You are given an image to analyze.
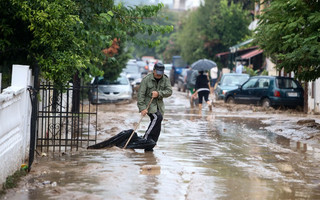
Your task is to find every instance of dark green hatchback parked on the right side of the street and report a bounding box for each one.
[224,76,303,107]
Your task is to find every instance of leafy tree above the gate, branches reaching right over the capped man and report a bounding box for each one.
[0,0,172,85]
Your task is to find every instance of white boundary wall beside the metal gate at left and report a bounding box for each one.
[0,65,32,186]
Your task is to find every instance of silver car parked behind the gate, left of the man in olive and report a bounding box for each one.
[89,73,132,104]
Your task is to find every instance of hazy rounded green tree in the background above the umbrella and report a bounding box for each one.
[178,0,250,63]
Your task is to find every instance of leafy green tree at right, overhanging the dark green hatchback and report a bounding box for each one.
[255,0,320,81]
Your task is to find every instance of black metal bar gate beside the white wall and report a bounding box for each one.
[36,82,98,152]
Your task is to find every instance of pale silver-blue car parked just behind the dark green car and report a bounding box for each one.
[214,73,250,100]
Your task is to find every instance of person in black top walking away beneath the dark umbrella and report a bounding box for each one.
[193,71,212,111]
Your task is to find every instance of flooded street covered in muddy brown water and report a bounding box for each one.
[3,91,320,200]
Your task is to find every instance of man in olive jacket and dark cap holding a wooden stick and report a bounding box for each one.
[137,63,172,151]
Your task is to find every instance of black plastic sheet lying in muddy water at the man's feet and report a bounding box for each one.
[87,129,156,149]
